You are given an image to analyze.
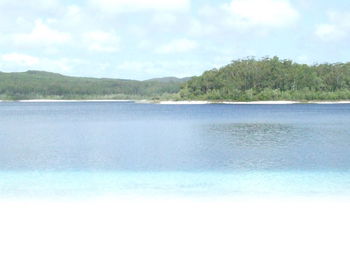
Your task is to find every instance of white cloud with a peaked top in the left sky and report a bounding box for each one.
[13,19,71,47]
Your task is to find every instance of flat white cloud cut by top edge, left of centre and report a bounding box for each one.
[90,0,190,12]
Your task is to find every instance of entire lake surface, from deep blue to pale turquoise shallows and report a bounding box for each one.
[0,102,350,196]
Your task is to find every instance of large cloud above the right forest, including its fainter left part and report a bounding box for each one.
[187,0,300,38]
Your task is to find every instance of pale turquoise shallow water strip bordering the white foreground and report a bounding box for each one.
[0,171,350,198]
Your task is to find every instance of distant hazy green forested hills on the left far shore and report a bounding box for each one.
[0,71,188,100]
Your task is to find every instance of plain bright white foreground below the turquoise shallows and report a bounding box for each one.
[0,198,350,263]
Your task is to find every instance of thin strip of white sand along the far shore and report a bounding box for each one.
[0,99,350,105]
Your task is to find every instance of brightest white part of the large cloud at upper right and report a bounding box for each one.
[224,0,299,27]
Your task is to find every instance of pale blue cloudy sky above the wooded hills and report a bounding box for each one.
[0,0,350,80]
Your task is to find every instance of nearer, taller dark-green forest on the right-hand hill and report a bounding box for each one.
[180,57,350,101]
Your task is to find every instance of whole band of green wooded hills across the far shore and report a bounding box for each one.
[0,57,350,101]
